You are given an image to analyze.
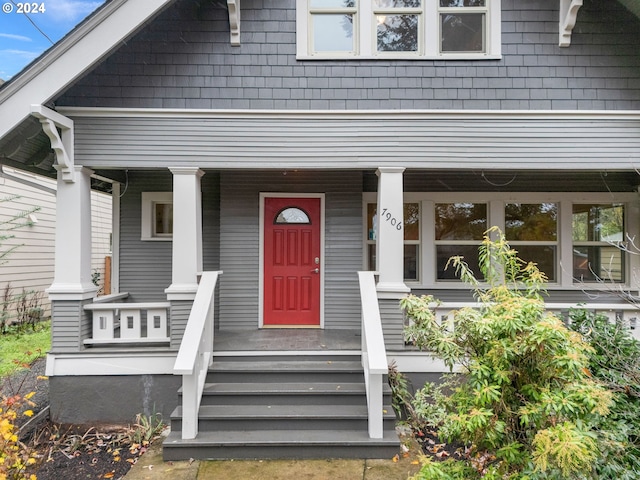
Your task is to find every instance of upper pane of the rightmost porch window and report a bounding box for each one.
[572,204,624,242]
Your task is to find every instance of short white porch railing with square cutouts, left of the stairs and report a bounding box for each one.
[83,293,170,345]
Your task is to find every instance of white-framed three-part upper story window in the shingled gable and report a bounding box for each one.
[296,0,501,59]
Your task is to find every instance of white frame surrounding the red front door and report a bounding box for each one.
[258,192,325,328]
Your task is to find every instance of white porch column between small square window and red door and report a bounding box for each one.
[165,167,204,300]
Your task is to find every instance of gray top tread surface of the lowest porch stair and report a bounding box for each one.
[163,430,399,447]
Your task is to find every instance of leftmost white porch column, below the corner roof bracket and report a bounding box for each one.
[47,166,98,300]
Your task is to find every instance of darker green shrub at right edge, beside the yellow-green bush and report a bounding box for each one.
[569,308,640,480]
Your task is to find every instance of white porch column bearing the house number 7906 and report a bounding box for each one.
[376,167,409,296]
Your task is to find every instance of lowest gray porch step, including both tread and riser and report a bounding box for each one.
[163,430,400,461]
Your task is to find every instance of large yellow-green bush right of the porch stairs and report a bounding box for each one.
[401,229,612,480]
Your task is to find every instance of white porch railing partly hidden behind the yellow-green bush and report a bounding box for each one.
[430,302,640,340]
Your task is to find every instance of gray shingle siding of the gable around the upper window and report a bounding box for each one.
[56,0,640,110]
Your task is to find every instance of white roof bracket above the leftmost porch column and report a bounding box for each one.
[31,105,75,183]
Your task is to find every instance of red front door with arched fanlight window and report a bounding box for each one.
[263,198,321,327]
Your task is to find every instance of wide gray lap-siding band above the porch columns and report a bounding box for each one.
[71,112,640,170]
